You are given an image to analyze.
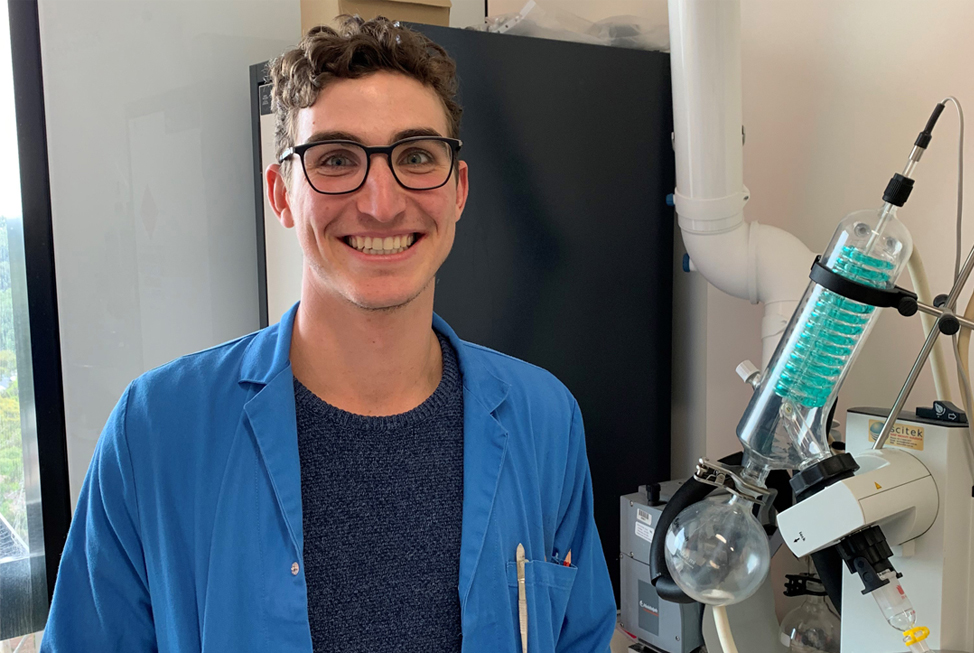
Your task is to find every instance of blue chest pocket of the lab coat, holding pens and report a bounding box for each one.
[507,561,578,653]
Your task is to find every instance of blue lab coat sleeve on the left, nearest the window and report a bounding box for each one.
[41,386,158,653]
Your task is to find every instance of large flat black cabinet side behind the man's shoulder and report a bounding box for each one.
[415,26,675,595]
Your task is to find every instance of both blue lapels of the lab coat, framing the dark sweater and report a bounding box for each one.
[240,304,510,604]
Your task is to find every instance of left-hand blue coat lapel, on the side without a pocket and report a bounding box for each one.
[240,304,304,559]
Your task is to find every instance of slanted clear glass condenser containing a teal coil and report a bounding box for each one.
[737,204,913,469]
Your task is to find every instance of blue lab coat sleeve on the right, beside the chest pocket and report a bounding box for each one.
[555,400,616,653]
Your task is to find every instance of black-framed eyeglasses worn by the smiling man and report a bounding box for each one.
[278,136,463,195]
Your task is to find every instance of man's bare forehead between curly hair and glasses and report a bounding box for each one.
[295,72,449,145]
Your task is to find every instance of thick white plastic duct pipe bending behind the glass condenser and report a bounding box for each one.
[669,0,815,368]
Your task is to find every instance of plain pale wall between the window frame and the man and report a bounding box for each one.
[39,0,300,502]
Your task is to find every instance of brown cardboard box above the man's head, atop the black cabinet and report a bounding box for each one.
[301,0,452,34]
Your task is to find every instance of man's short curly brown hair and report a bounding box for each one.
[269,16,463,183]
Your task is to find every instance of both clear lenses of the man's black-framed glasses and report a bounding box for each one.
[304,140,453,193]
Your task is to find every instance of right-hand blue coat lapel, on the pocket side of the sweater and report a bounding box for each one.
[433,314,510,604]
